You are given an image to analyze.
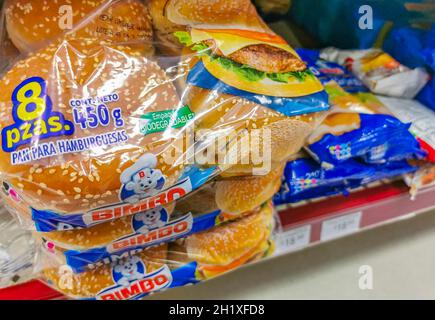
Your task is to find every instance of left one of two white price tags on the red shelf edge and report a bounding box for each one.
[276,225,311,252]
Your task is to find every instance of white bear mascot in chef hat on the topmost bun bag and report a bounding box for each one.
[120,153,166,203]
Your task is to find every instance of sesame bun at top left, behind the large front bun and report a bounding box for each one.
[5,0,154,54]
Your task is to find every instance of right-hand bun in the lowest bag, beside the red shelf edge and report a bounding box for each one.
[169,203,273,280]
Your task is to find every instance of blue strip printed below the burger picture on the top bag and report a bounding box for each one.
[187,61,329,117]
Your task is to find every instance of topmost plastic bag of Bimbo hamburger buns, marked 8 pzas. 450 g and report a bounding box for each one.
[0,0,328,232]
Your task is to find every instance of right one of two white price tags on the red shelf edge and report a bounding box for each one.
[320,212,362,241]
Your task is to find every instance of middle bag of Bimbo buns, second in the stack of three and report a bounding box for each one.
[3,167,283,272]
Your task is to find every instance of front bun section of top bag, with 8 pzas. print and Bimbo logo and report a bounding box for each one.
[0,35,225,231]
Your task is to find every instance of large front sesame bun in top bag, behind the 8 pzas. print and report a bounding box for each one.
[0,40,183,214]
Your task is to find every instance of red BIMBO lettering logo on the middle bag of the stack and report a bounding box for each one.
[107,214,193,253]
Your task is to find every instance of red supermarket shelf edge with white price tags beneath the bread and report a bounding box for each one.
[0,181,435,300]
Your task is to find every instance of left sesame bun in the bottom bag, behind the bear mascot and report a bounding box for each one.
[43,245,167,299]
